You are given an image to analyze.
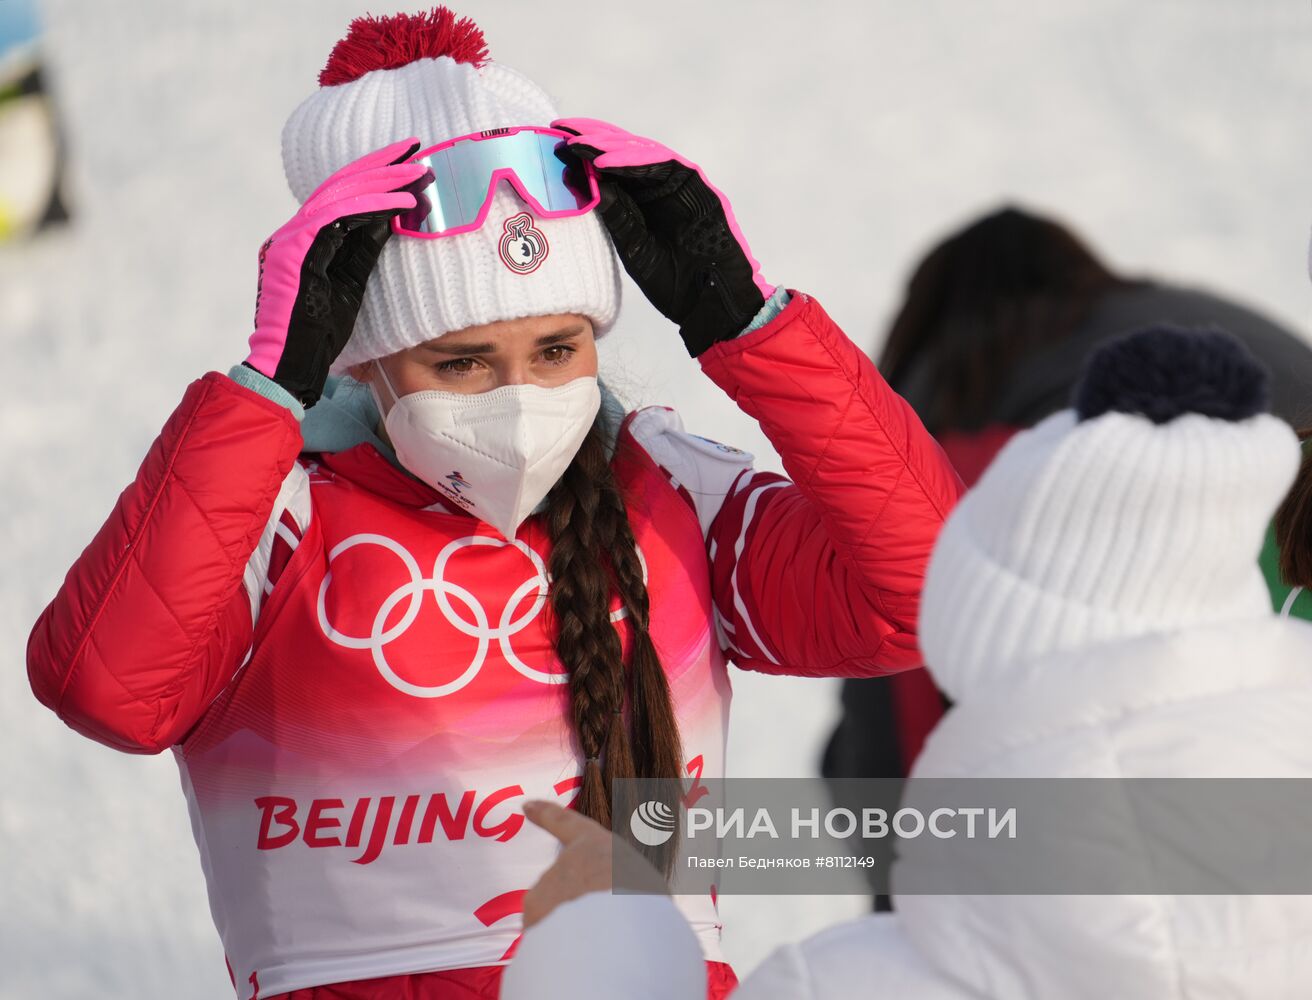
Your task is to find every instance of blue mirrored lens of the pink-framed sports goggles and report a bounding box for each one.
[398,131,592,232]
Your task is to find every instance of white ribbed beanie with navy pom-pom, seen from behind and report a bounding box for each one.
[920,328,1299,699]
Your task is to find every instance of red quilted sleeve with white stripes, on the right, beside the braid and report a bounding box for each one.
[701,293,962,677]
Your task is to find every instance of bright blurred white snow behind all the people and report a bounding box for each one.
[0,0,1312,1000]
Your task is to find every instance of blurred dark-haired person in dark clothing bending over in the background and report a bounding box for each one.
[823,206,1312,909]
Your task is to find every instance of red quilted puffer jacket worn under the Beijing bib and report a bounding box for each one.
[28,286,960,997]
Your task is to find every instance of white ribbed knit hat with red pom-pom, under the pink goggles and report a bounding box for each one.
[282,7,619,373]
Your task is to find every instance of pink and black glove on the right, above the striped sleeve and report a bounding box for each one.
[551,118,774,357]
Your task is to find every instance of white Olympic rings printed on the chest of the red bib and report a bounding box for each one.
[318,531,647,698]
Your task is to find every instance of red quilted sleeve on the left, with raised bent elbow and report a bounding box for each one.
[28,371,300,753]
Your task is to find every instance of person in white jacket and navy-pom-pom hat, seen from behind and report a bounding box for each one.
[502,328,1312,1000]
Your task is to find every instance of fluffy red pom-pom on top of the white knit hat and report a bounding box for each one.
[319,7,488,87]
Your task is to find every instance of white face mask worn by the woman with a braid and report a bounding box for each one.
[370,361,601,539]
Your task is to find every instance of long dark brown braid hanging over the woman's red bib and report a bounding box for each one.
[546,416,684,874]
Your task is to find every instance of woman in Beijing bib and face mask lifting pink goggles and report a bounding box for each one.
[28,8,960,1000]
